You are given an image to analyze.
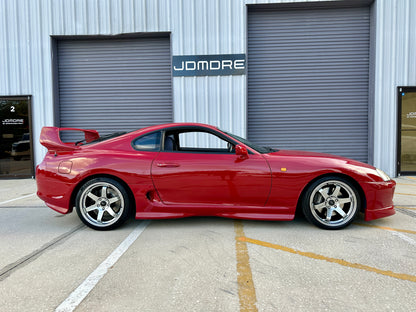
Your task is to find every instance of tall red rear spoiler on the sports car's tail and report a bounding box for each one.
[39,127,100,152]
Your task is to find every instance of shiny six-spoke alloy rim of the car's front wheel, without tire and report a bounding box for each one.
[309,180,358,228]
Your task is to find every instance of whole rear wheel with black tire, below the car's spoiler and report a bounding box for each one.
[75,178,130,231]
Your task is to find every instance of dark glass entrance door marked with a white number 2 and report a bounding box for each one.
[0,96,34,178]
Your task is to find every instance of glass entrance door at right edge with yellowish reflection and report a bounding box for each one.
[398,87,416,174]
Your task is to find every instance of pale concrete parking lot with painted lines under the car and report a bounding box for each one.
[0,176,416,312]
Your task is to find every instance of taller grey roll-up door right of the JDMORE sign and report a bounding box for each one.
[248,7,370,162]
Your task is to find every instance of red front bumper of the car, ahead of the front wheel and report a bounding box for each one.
[362,180,396,221]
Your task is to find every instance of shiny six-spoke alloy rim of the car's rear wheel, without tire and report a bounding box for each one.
[78,182,125,227]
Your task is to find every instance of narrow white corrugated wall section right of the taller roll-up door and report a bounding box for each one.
[374,0,416,175]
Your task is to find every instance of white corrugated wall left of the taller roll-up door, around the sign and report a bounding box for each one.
[0,0,246,167]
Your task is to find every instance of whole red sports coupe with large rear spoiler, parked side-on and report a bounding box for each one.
[36,123,396,230]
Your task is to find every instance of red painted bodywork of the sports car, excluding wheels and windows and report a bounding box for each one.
[36,123,396,220]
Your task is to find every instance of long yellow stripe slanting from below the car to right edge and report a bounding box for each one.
[239,237,416,283]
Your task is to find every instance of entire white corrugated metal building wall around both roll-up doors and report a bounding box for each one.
[0,0,416,175]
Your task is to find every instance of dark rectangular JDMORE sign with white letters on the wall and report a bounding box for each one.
[172,54,246,77]
